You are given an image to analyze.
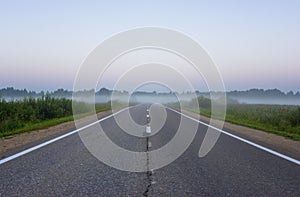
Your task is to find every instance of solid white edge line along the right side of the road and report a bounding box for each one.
[168,108,300,165]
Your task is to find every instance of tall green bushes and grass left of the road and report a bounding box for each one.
[0,95,113,137]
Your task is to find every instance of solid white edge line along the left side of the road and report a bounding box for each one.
[0,107,130,165]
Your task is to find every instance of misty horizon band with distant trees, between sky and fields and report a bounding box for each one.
[0,87,300,105]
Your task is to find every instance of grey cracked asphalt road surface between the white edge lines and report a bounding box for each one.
[0,105,300,196]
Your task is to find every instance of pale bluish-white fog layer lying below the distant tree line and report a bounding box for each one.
[0,90,300,106]
